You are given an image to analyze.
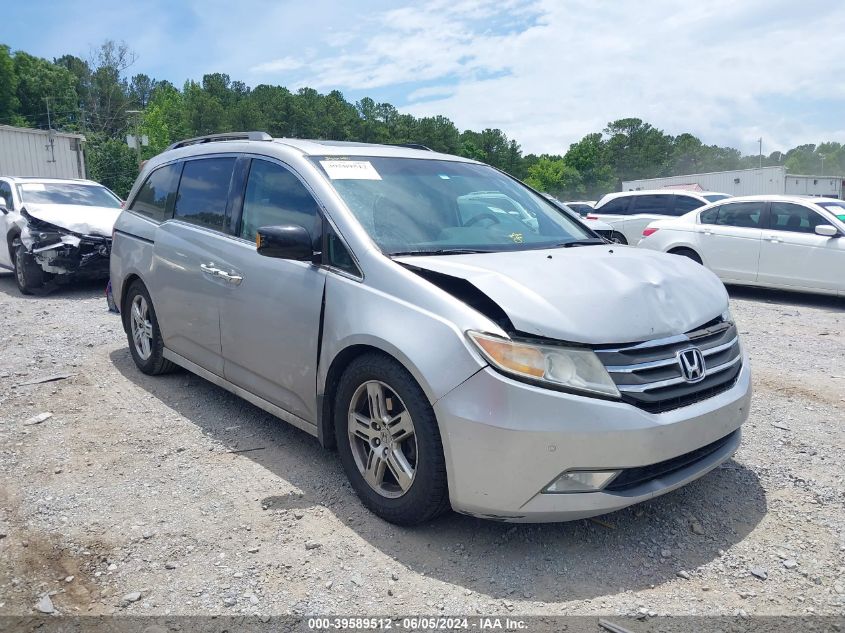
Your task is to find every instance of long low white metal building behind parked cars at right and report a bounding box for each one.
[622,167,845,198]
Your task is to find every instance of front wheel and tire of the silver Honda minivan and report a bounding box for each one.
[334,353,450,526]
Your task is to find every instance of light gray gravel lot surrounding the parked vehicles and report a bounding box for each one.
[0,274,845,616]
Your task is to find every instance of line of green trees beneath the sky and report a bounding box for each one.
[0,41,845,199]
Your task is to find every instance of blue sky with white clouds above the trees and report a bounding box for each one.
[6,0,845,154]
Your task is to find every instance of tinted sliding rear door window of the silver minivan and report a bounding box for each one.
[173,157,235,231]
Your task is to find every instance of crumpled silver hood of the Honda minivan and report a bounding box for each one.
[396,244,728,345]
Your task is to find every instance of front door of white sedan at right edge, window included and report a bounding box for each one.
[758,202,845,292]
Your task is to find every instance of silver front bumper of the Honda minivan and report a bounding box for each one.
[434,348,751,522]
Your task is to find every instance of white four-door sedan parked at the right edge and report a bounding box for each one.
[637,196,845,296]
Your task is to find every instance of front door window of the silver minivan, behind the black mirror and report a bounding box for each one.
[240,159,318,240]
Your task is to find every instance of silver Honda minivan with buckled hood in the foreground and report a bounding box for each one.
[111,132,751,525]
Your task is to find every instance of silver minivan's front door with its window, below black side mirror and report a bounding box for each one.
[220,158,326,423]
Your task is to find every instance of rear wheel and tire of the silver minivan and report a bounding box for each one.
[123,280,176,376]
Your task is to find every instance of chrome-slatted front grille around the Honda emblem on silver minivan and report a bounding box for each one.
[595,319,742,413]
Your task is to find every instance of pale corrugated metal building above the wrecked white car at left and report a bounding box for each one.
[0,125,85,178]
